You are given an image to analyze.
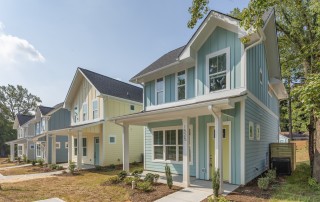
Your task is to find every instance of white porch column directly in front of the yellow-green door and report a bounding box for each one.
[214,110,223,194]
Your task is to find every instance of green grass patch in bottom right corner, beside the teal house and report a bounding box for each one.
[271,163,320,201]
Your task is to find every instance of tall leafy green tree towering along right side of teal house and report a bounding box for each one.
[188,0,320,182]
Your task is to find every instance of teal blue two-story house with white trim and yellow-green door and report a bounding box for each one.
[113,10,287,189]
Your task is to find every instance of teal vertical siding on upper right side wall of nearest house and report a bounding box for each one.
[247,44,279,116]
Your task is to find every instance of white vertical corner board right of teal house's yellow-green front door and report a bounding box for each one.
[240,100,246,184]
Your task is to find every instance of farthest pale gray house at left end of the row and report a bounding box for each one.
[6,114,35,161]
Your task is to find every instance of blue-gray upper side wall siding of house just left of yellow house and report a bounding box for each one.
[48,108,70,131]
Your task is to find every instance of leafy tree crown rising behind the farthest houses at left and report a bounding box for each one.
[0,85,41,121]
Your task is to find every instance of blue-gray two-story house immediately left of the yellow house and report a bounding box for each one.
[32,103,70,164]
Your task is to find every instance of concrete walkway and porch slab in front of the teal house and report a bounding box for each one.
[142,171,239,202]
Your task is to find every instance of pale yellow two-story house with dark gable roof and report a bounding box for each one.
[64,68,143,169]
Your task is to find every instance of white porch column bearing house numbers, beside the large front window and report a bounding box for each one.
[182,117,190,187]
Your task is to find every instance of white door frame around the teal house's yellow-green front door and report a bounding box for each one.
[207,121,232,183]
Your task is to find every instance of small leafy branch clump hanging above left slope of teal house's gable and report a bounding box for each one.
[188,0,209,29]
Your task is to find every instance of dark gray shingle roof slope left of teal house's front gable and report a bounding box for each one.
[131,46,185,80]
